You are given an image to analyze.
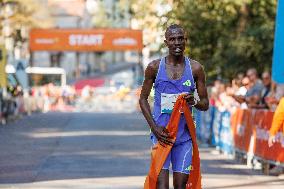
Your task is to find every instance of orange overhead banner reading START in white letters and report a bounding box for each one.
[30,29,143,52]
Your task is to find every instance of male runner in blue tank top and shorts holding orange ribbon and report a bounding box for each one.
[139,24,209,189]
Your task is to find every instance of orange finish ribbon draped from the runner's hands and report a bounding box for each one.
[144,95,201,189]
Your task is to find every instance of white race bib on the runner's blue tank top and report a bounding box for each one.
[161,93,180,114]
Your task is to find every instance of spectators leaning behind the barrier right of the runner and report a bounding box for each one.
[209,68,284,113]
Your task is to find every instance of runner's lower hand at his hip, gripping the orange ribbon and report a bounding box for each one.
[152,126,174,147]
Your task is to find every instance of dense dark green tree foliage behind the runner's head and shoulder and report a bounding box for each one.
[166,0,277,79]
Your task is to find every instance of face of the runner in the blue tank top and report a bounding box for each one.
[165,28,186,56]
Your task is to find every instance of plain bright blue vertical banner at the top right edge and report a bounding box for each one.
[272,0,284,83]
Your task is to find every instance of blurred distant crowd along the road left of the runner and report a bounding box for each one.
[0,83,137,124]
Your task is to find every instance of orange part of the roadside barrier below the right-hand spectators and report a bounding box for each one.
[231,109,284,163]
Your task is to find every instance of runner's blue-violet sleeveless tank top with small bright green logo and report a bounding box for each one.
[151,57,195,144]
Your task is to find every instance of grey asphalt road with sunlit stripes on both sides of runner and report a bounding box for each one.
[0,112,284,189]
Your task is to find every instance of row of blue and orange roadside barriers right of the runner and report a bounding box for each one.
[196,108,284,166]
